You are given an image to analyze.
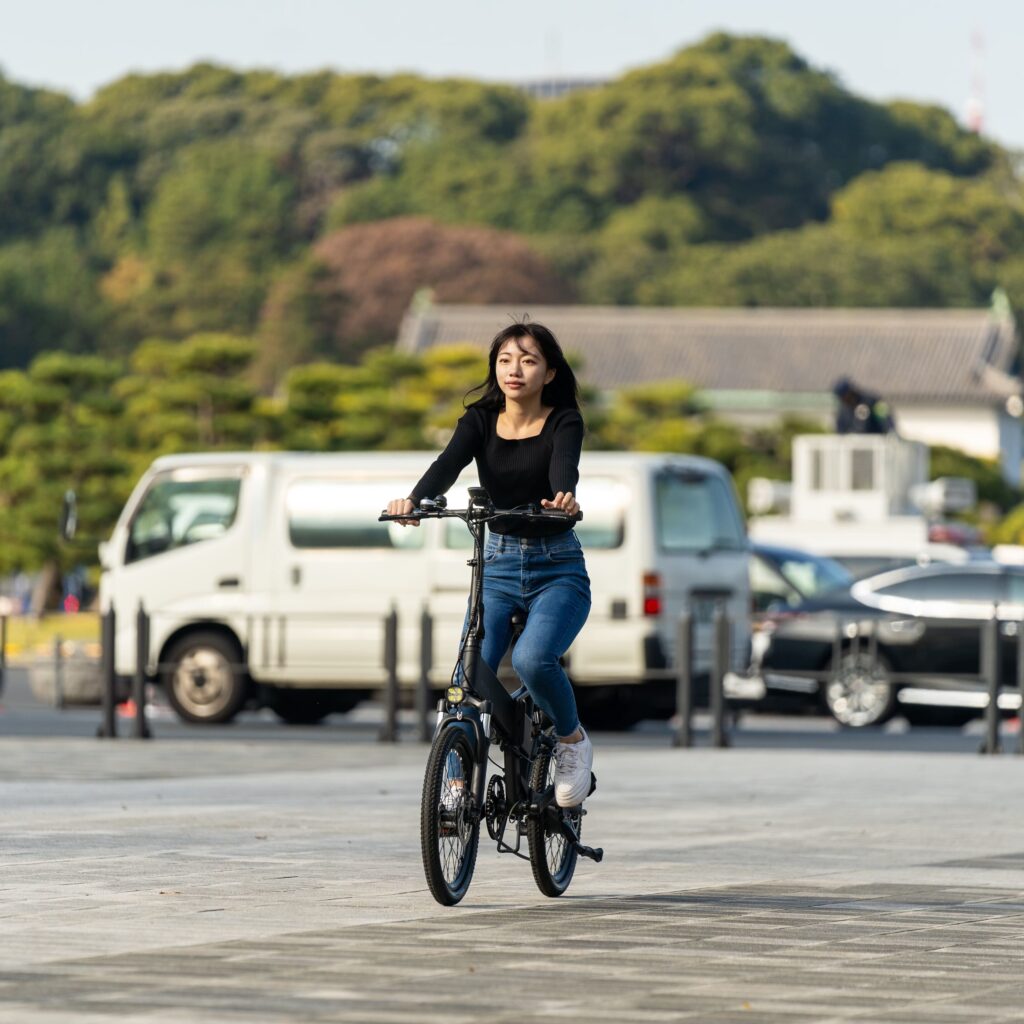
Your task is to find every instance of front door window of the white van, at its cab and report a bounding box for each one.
[125,476,242,563]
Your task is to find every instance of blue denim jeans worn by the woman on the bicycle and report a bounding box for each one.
[471,531,590,736]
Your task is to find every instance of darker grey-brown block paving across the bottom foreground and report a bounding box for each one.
[0,886,1024,1024]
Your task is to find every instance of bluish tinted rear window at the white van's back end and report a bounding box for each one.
[654,470,746,551]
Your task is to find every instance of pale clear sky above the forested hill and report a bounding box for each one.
[8,0,1024,150]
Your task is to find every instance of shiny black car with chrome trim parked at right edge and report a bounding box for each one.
[754,561,1024,727]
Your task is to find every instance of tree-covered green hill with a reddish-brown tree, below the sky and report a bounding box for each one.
[0,35,1024,376]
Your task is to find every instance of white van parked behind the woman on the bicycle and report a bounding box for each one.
[100,452,750,726]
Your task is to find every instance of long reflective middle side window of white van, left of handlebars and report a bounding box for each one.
[285,478,425,548]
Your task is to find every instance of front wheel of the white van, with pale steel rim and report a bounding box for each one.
[166,633,249,725]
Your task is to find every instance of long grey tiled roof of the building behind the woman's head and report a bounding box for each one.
[398,305,1020,402]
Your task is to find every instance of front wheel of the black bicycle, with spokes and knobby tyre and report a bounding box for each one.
[420,728,480,906]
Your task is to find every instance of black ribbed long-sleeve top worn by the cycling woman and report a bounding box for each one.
[409,406,584,537]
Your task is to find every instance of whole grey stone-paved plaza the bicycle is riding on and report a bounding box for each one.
[0,736,1024,1024]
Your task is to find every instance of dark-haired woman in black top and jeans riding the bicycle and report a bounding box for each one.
[387,323,594,807]
